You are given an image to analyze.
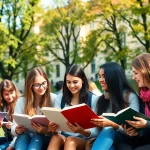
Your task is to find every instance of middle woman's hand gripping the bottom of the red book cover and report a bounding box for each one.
[67,122,91,136]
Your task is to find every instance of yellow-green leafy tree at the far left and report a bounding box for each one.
[0,0,50,80]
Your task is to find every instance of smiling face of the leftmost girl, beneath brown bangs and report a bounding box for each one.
[2,90,16,103]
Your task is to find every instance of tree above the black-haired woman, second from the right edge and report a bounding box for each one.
[87,0,130,69]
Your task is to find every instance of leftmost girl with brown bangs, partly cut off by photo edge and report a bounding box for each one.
[0,80,20,150]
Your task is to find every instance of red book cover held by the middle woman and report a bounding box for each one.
[61,104,99,129]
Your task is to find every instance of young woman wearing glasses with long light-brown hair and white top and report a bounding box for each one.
[11,67,56,150]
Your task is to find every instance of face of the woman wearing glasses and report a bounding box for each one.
[32,75,48,96]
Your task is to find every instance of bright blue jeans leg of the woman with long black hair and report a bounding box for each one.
[92,127,117,150]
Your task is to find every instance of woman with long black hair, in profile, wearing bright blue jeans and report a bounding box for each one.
[86,62,139,150]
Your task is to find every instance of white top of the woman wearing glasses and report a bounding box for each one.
[11,93,57,136]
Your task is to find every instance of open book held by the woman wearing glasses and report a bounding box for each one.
[13,114,49,133]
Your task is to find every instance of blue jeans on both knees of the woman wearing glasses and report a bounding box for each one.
[15,133,44,150]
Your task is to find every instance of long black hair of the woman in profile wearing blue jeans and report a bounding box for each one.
[97,62,135,115]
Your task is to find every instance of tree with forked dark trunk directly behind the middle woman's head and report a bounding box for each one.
[43,0,94,68]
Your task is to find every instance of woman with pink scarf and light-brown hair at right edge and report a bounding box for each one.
[117,53,150,150]
